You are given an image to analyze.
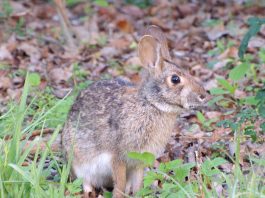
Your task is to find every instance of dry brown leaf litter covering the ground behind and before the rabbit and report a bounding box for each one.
[0,0,265,196]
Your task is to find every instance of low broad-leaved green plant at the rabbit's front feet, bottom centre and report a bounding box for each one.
[129,152,242,197]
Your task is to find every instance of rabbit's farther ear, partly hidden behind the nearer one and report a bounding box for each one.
[144,25,171,60]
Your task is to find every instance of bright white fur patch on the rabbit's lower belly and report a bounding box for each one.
[73,153,112,188]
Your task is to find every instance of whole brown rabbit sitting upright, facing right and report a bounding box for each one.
[62,26,208,198]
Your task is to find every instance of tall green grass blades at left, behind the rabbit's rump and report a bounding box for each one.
[0,74,81,198]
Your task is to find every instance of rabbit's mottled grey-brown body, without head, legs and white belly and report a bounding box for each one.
[63,79,174,164]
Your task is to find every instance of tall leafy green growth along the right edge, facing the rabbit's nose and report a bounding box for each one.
[206,18,265,192]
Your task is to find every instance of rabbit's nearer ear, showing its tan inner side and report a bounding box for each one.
[138,35,163,71]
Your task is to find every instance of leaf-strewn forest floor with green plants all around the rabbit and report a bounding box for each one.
[0,0,265,197]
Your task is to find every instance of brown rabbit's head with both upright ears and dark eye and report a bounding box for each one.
[138,26,209,112]
